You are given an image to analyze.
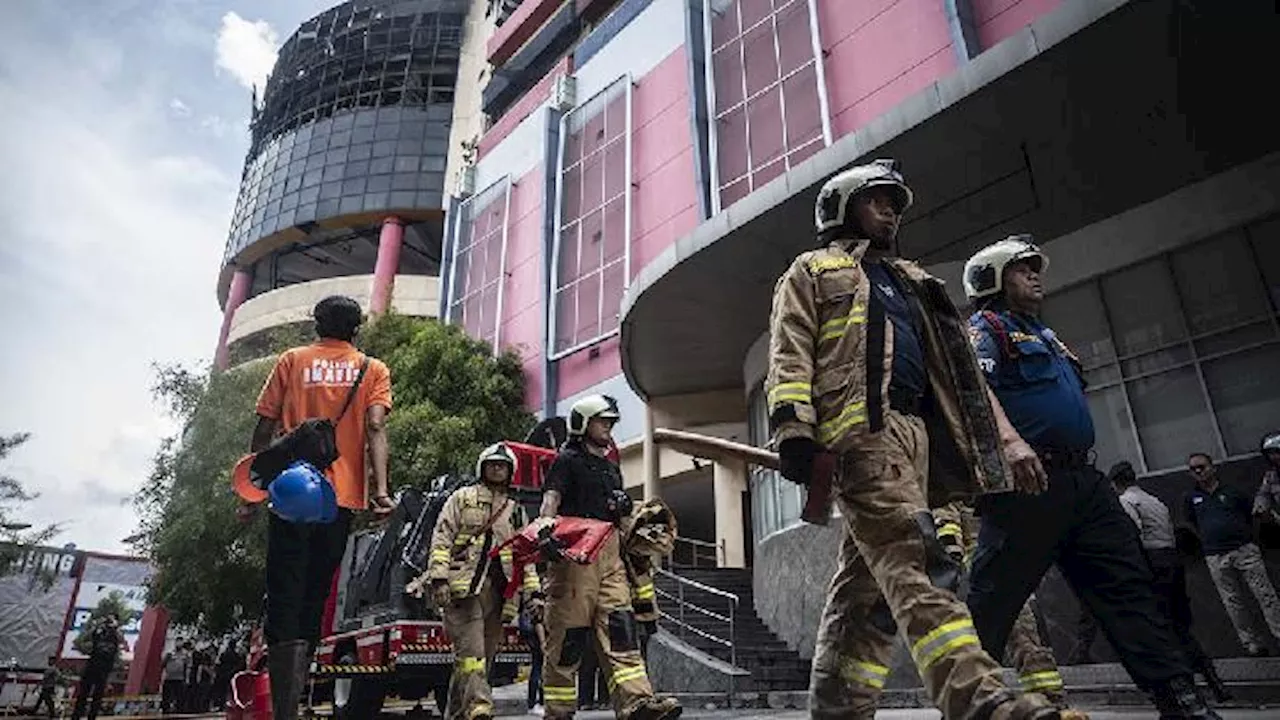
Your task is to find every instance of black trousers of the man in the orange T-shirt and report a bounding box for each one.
[264,509,351,646]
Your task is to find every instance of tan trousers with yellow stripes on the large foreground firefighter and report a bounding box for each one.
[809,410,1029,720]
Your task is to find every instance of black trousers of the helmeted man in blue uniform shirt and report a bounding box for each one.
[969,466,1190,691]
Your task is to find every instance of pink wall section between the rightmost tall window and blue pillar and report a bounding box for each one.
[818,0,956,137]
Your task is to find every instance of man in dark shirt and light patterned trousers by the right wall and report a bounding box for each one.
[1183,452,1280,657]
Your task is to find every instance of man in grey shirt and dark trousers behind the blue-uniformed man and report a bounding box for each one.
[1107,462,1231,702]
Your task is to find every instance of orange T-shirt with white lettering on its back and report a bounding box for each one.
[249,340,392,510]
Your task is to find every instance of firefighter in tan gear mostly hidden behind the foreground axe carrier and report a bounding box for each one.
[933,500,1066,708]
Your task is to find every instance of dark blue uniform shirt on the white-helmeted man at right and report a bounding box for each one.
[969,311,1093,450]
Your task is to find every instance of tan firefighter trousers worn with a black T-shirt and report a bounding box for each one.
[543,533,653,720]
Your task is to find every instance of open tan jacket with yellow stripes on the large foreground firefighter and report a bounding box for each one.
[765,240,1014,505]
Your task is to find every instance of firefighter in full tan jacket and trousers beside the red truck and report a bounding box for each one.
[406,442,541,720]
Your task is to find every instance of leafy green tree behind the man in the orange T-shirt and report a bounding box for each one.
[136,314,532,634]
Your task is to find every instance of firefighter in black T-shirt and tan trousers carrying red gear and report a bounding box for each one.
[538,395,681,720]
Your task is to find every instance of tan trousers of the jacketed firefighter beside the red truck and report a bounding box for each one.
[444,578,503,720]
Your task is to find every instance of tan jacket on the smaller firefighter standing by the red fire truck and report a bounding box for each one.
[426,483,541,601]
